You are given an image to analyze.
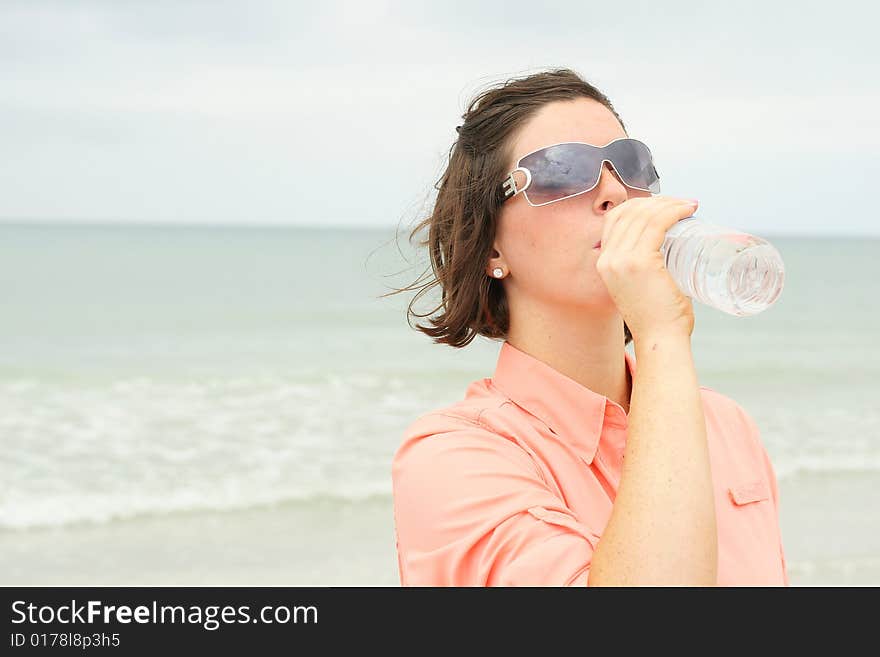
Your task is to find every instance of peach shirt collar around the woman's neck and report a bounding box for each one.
[492,340,636,463]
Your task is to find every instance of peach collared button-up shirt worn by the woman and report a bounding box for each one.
[391,342,789,586]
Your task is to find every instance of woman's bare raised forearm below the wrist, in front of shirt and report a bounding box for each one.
[589,335,718,586]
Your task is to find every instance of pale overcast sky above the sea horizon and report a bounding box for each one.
[0,0,880,236]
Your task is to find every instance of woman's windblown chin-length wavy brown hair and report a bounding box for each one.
[382,68,632,347]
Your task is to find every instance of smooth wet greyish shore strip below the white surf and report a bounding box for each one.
[0,473,880,586]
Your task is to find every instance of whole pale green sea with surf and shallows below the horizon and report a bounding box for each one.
[0,223,880,586]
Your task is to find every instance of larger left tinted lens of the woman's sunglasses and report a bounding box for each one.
[519,143,602,205]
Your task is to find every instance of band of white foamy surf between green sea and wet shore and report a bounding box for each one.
[0,371,880,529]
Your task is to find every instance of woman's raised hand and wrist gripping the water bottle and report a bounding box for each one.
[596,196,698,341]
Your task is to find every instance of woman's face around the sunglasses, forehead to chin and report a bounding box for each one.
[486,98,651,308]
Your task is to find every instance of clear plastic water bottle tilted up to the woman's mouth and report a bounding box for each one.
[660,216,785,317]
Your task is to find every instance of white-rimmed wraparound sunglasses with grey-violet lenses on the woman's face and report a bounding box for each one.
[501,138,660,207]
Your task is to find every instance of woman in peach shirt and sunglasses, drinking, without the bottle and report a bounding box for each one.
[392,69,788,586]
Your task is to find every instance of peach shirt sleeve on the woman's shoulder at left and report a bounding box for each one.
[392,425,599,586]
